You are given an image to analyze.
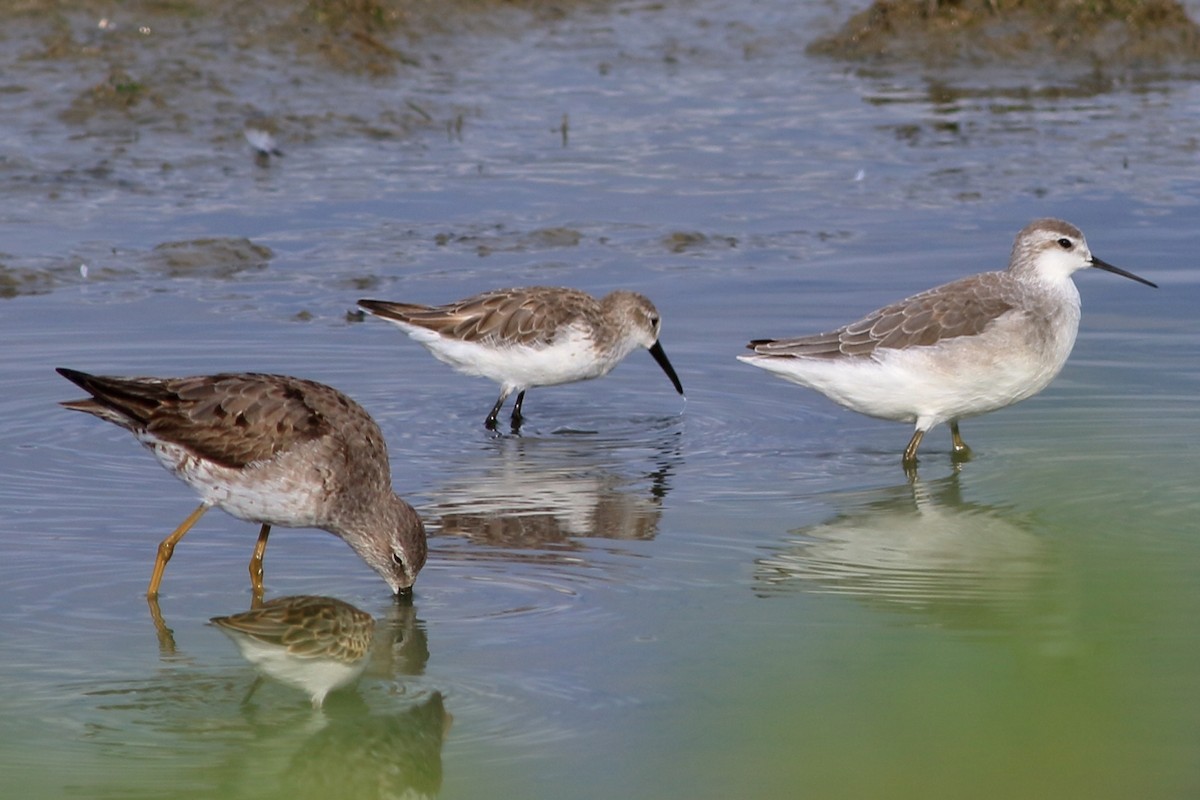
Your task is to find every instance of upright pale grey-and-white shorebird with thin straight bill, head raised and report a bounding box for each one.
[738,219,1157,468]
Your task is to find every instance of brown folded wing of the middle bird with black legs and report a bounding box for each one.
[362,287,595,345]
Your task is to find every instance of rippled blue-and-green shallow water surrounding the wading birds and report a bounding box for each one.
[0,0,1200,798]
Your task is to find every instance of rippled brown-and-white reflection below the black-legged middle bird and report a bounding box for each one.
[434,437,674,558]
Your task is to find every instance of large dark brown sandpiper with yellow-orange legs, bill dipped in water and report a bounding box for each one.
[59,368,426,597]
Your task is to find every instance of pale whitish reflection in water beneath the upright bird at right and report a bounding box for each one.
[755,470,1057,627]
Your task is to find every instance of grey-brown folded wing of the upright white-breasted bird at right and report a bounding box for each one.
[748,272,1013,359]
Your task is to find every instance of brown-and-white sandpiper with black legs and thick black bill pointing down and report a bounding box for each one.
[359,287,683,429]
